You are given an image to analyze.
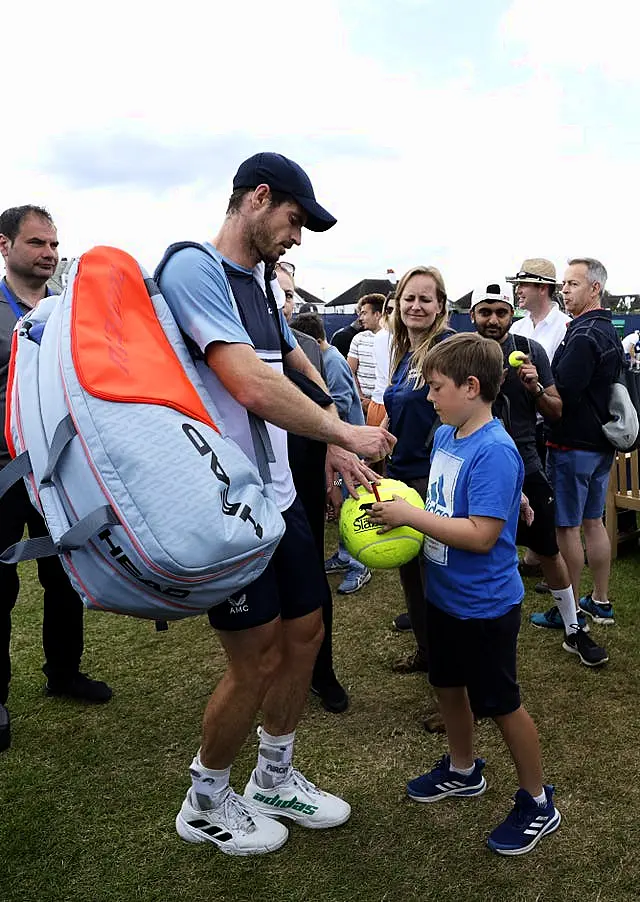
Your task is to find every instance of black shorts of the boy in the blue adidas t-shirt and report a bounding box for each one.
[427,601,520,717]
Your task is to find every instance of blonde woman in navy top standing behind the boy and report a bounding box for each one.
[383,266,453,688]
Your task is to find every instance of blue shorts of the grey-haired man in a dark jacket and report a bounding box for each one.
[547,448,614,527]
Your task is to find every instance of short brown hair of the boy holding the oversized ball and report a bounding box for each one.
[423,332,504,404]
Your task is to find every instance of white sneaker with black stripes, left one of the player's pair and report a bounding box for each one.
[176,788,289,855]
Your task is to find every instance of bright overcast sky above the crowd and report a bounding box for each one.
[5,0,640,300]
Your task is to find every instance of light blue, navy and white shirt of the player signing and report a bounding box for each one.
[160,244,297,511]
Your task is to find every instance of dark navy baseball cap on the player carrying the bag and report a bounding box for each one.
[233,152,337,232]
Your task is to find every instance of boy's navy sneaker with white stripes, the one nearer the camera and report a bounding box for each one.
[487,786,561,855]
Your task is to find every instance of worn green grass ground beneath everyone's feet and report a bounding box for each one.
[0,532,640,902]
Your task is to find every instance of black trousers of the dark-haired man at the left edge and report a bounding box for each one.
[0,482,84,704]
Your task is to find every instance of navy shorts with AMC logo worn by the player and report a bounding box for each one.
[209,497,324,631]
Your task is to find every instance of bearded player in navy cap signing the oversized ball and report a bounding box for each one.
[156,153,395,856]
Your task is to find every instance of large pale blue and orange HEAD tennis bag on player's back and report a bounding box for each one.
[0,247,284,620]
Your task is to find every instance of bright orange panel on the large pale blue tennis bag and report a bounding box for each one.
[71,247,217,429]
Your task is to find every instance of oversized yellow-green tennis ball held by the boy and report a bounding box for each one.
[340,479,424,570]
